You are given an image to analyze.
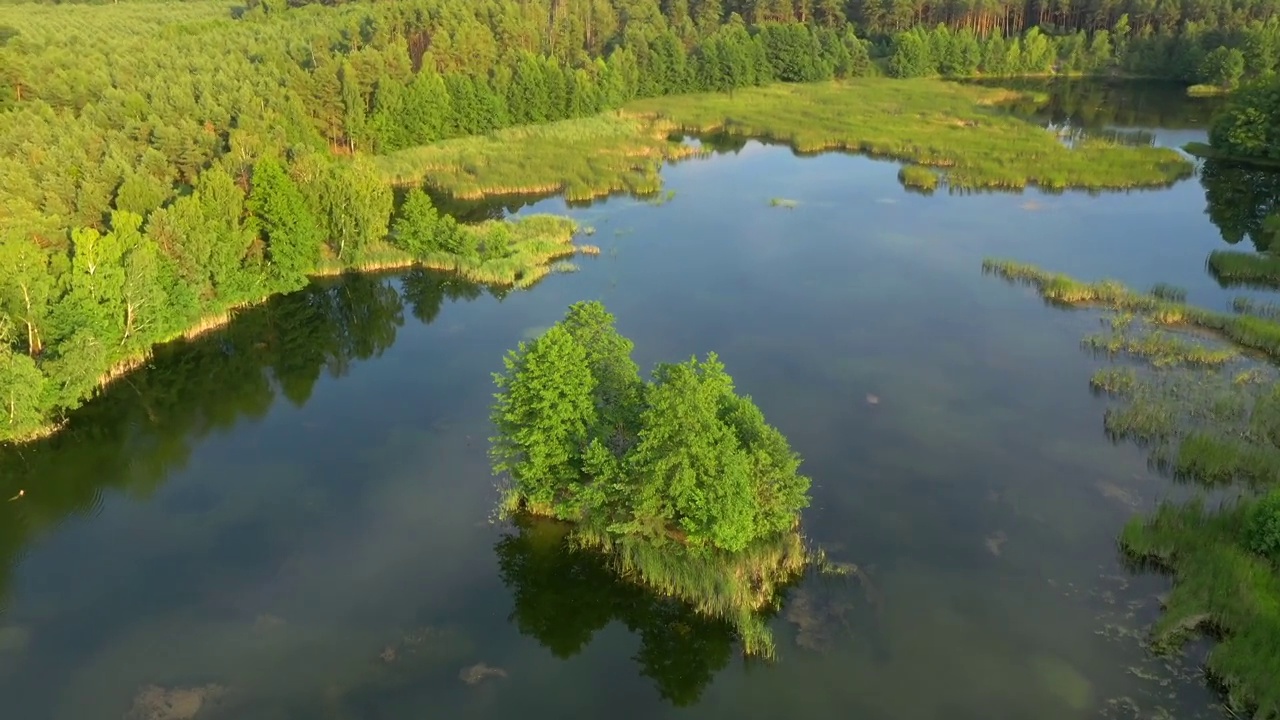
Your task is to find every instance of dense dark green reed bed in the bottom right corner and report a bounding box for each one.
[1120,501,1280,720]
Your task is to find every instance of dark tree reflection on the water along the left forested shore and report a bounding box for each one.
[0,270,496,612]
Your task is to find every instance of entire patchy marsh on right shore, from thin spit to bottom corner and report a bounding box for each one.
[983,260,1280,719]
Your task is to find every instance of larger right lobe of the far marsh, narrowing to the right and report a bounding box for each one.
[625,78,1193,190]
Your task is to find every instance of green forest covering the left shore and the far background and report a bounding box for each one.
[0,0,1280,441]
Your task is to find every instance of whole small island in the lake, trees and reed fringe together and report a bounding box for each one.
[490,302,818,657]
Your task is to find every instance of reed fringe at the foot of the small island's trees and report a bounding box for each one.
[571,525,803,659]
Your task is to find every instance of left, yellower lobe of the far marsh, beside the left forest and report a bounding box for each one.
[374,113,704,201]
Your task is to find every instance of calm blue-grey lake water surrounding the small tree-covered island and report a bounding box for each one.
[0,79,1276,720]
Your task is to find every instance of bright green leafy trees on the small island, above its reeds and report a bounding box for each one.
[492,295,809,555]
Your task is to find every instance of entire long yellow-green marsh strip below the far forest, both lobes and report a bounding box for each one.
[374,78,1192,201]
